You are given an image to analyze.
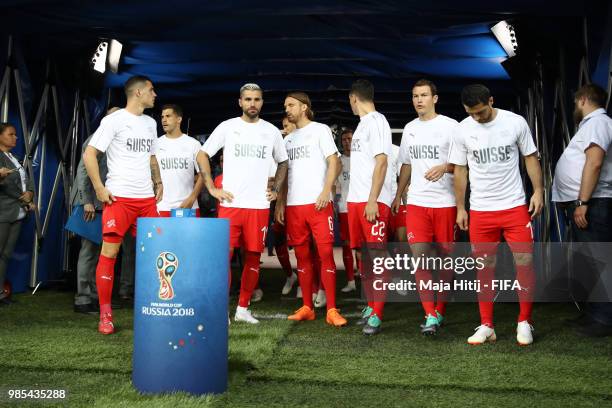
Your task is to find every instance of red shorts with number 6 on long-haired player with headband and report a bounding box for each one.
[285,204,334,245]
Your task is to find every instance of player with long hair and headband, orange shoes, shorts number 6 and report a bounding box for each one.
[275,92,346,327]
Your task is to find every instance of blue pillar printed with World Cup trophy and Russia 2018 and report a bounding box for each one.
[132,218,229,394]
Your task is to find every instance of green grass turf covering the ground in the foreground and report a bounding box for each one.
[0,271,612,407]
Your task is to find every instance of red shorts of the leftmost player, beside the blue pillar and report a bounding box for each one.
[102,197,159,244]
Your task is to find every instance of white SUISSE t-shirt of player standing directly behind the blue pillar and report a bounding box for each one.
[153,134,202,211]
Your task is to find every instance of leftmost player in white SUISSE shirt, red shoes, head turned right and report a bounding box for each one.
[83,76,163,334]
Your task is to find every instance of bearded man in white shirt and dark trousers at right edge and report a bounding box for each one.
[552,84,612,337]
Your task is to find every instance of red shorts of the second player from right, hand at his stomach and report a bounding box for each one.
[406,204,457,250]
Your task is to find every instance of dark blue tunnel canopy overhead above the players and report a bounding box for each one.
[0,0,607,133]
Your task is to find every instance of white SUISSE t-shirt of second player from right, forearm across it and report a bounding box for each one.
[399,115,458,208]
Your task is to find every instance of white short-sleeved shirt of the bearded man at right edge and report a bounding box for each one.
[552,108,612,202]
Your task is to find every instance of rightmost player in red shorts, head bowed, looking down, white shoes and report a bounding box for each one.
[449,84,544,346]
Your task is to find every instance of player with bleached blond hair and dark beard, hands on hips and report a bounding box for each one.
[197,84,287,324]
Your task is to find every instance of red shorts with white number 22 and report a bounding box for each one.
[347,203,391,248]
